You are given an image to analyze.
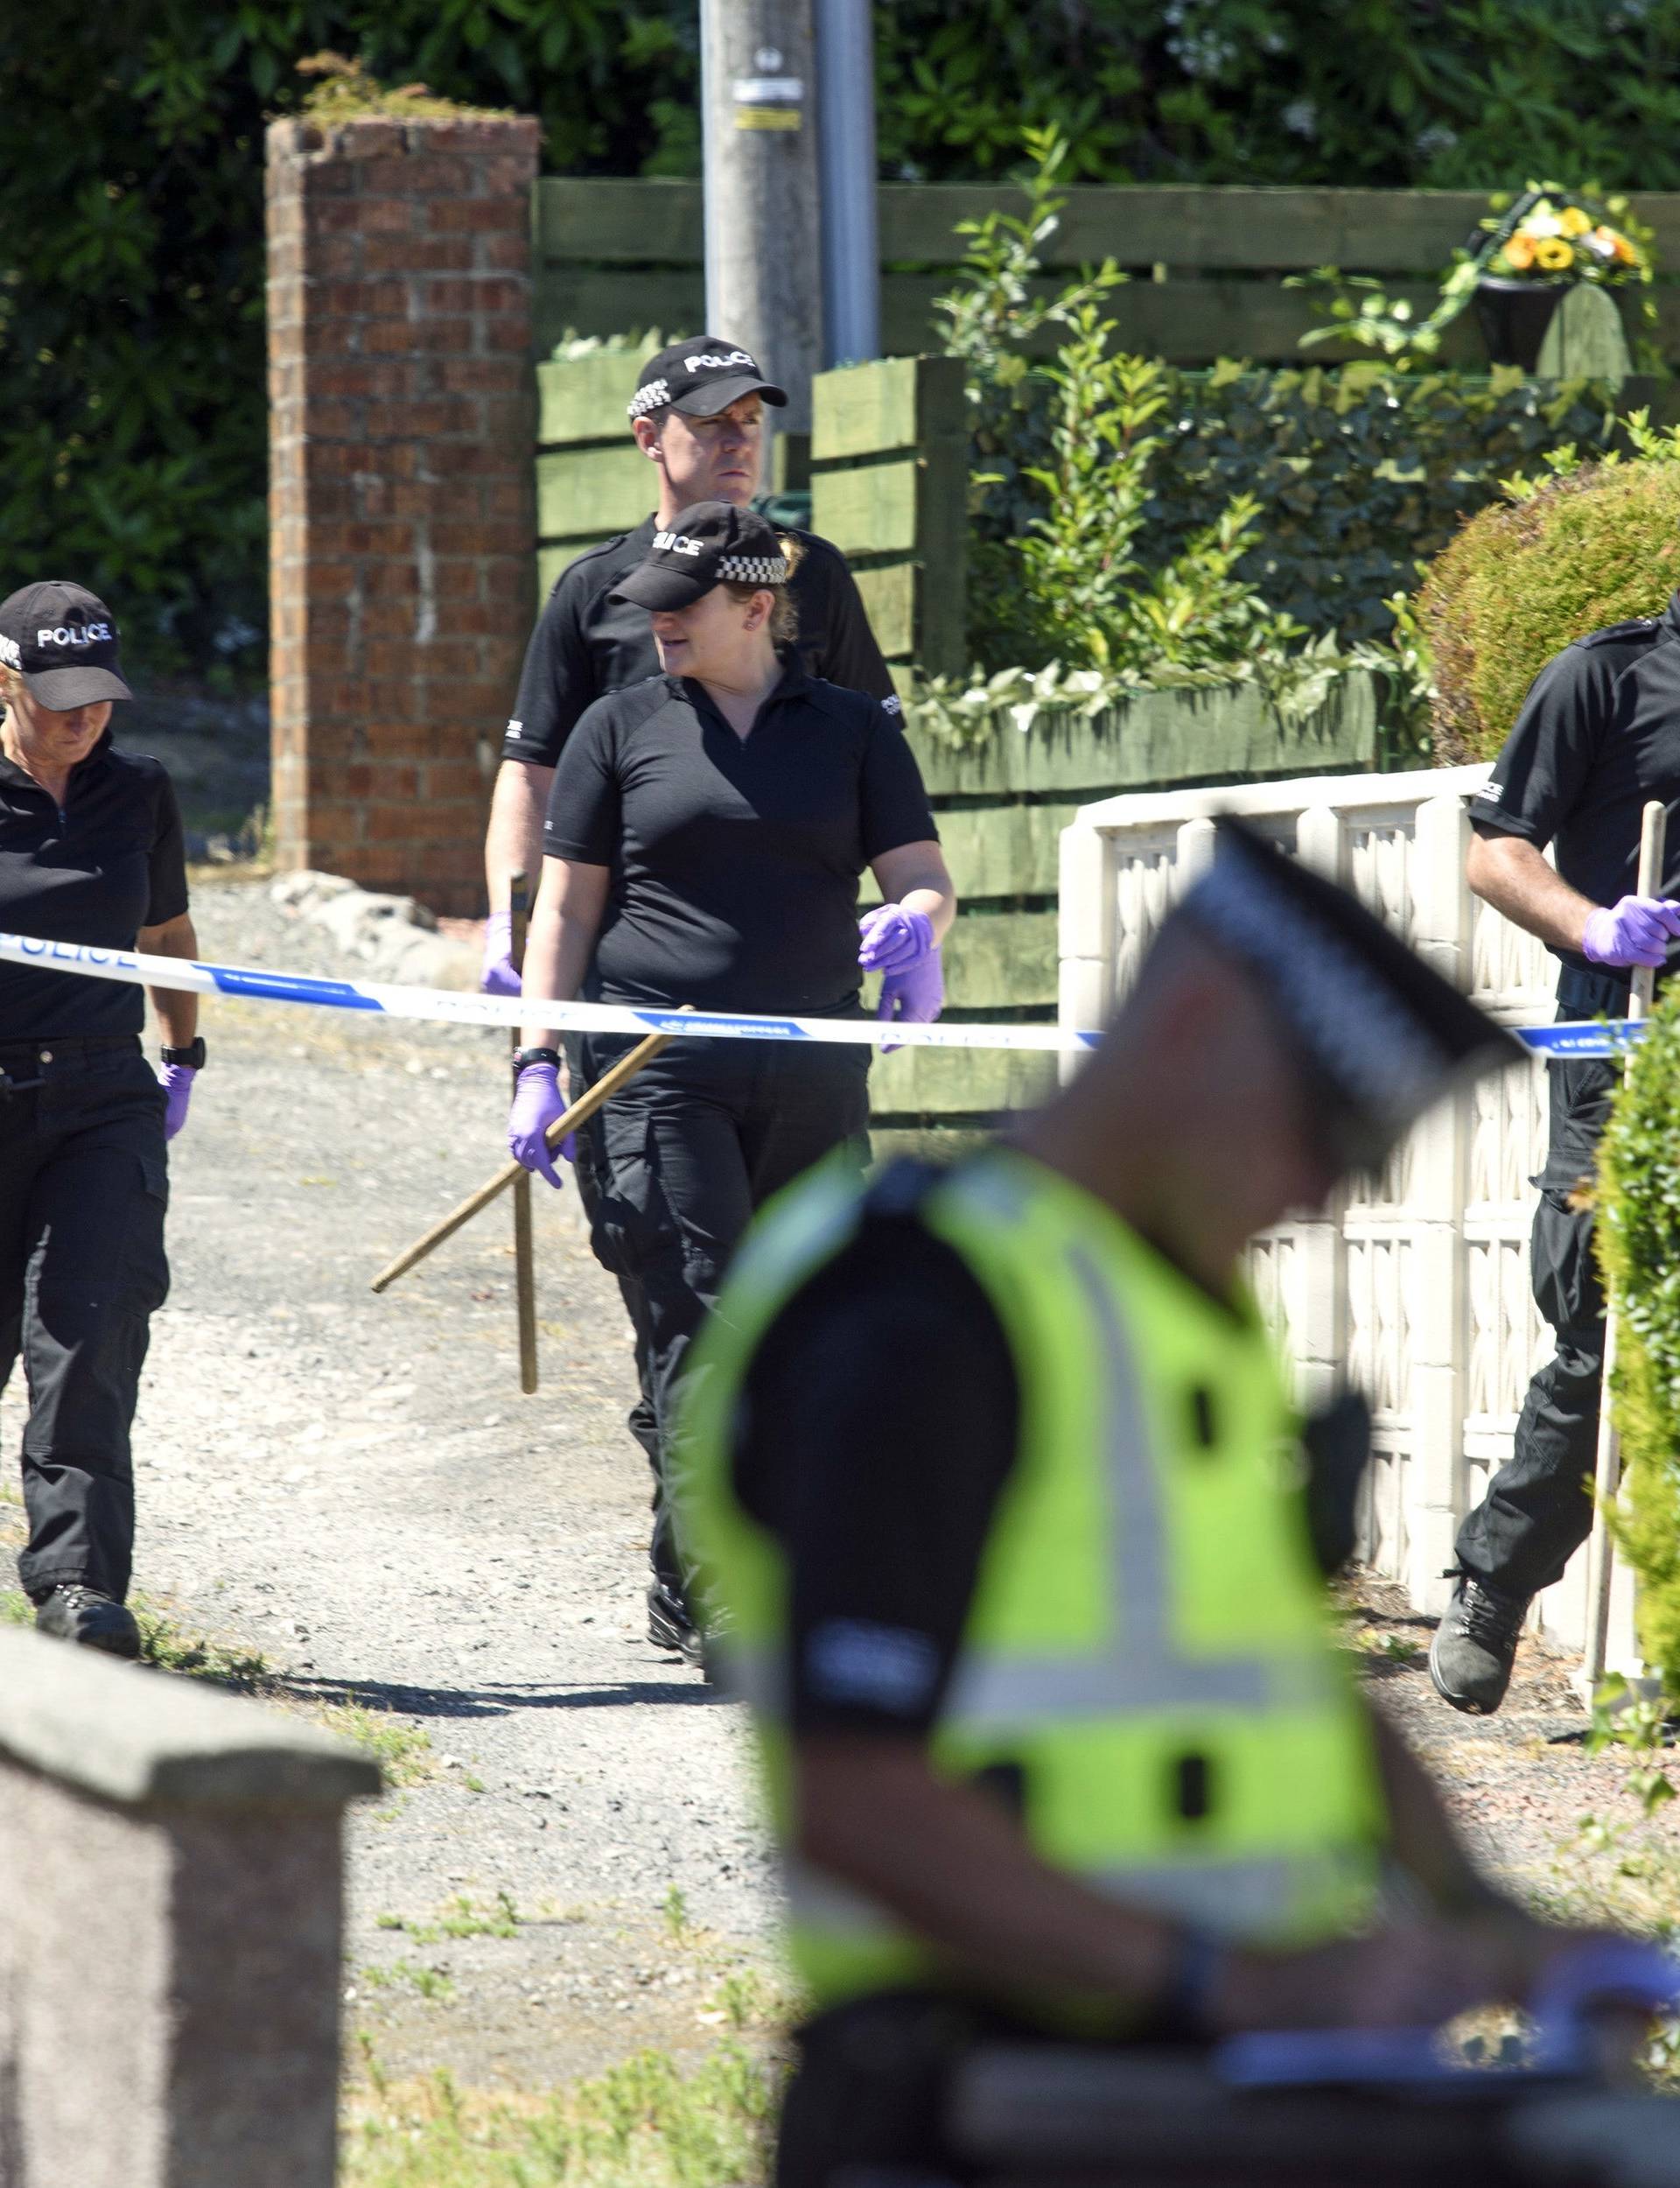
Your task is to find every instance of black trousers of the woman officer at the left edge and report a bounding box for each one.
[0,1040,169,1602]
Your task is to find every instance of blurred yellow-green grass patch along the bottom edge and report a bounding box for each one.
[341,2044,781,2188]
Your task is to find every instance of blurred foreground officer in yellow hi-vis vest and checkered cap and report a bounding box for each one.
[687,823,1636,2188]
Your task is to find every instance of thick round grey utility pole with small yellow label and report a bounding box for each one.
[700,0,822,433]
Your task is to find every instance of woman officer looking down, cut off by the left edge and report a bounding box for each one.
[0,585,204,1657]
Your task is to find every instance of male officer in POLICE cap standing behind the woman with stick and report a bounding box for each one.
[484,335,897,996]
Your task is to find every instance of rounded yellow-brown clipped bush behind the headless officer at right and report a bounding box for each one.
[1416,431,1680,764]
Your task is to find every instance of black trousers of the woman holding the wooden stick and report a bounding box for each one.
[567,1035,871,1597]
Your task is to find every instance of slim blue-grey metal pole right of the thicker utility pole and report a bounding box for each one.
[816,0,882,366]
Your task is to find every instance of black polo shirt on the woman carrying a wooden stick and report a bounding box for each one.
[545,665,939,1018]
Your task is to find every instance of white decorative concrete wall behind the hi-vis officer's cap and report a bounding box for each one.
[1061,766,1632,1666]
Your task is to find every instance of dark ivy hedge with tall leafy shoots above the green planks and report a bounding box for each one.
[939,131,1614,700]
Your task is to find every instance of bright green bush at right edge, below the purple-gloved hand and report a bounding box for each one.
[1597,989,1680,1696]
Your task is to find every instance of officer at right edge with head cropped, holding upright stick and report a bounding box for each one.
[1429,595,1680,1714]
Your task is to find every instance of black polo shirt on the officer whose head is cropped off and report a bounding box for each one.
[1470,593,1680,980]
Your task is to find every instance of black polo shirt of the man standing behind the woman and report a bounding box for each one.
[501,516,900,768]
